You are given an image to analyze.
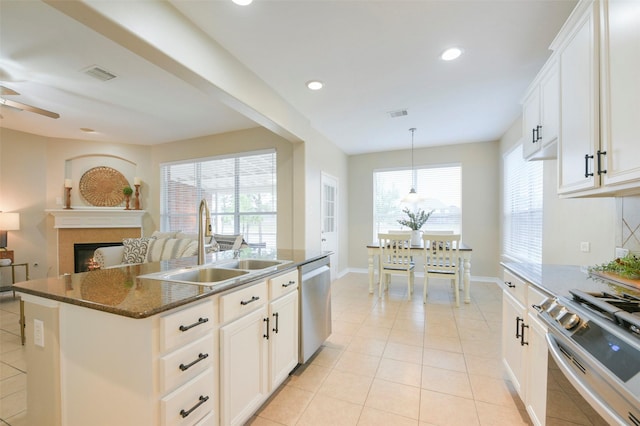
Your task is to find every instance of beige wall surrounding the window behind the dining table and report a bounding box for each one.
[348,142,500,277]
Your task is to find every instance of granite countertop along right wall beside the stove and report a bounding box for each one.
[501,262,640,297]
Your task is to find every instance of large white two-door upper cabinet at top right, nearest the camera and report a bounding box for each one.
[552,0,640,197]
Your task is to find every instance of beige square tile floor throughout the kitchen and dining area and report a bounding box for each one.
[0,273,529,426]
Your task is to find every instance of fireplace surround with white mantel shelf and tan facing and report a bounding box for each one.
[46,207,146,275]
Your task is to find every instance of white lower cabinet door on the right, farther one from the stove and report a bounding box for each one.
[502,291,526,401]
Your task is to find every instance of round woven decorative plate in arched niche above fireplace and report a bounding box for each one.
[80,166,129,207]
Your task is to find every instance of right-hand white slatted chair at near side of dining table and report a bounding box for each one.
[422,233,460,307]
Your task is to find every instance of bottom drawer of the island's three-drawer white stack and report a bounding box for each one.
[160,368,217,426]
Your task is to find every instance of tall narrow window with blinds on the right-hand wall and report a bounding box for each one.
[502,146,542,263]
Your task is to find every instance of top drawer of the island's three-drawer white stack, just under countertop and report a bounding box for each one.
[160,301,216,352]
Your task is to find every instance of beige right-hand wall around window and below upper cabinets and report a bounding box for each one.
[500,119,617,265]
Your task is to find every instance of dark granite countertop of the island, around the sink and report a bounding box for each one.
[13,249,330,318]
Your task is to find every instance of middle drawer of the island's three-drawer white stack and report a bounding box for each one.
[158,333,217,393]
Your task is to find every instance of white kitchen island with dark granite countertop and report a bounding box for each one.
[14,249,328,425]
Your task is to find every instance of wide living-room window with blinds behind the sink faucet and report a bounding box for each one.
[160,150,277,248]
